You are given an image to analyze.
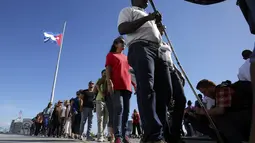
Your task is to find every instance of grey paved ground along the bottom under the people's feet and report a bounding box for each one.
[0,134,214,143]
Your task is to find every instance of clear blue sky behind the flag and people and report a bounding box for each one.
[0,0,254,132]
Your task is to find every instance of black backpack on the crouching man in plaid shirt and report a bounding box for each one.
[217,80,253,111]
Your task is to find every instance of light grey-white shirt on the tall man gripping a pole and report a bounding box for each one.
[118,6,162,46]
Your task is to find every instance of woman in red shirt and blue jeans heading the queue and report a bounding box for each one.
[105,37,135,143]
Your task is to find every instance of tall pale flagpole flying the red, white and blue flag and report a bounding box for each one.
[50,21,66,103]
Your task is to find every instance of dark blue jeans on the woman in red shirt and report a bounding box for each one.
[112,90,131,138]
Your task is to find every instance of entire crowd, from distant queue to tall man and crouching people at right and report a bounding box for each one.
[29,0,253,143]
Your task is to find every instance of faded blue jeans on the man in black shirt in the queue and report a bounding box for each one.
[80,107,93,137]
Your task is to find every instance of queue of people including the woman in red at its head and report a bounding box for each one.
[28,37,142,143]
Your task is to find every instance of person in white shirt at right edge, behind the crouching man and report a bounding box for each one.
[237,50,252,81]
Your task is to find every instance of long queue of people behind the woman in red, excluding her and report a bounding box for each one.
[30,79,142,142]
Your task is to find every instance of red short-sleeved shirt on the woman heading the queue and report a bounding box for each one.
[105,53,132,92]
